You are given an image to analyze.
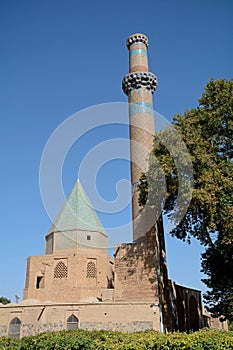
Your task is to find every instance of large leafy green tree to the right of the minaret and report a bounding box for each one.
[139,79,233,320]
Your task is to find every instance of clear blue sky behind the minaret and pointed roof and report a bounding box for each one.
[0,0,233,301]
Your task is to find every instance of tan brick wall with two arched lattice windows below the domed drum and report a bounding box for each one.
[24,249,109,302]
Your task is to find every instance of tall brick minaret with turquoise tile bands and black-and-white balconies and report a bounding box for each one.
[122,33,157,241]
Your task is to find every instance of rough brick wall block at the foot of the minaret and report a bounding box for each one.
[114,227,158,304]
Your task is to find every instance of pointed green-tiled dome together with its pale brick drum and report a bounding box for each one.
[46,180,107,254]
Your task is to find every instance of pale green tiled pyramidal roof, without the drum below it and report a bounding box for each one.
[48,180,105,234]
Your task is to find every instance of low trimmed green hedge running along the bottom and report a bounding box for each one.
[0,329,233,350]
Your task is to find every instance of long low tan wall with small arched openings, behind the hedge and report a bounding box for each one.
[0,301,159,337]
